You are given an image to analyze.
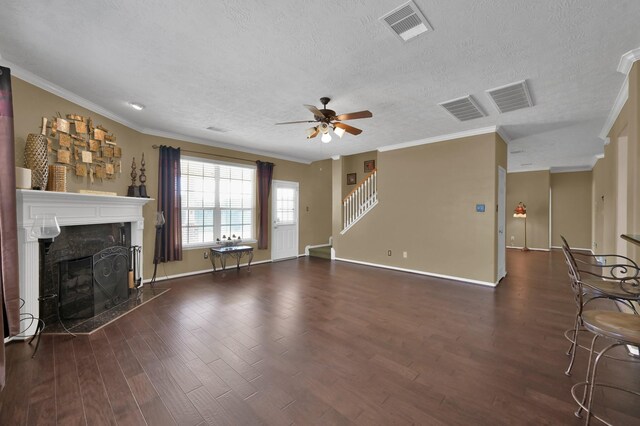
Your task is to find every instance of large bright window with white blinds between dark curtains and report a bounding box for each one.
[180,157,256,247]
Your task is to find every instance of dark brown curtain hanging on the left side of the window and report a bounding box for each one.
[158,145,182,262]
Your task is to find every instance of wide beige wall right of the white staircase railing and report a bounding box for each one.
[334,133,506,283]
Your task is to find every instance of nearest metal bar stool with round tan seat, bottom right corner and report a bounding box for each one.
[571,310,640,425]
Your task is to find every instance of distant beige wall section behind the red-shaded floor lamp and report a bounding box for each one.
[506,170,551,250]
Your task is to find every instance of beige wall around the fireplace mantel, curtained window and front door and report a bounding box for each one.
[12,78,332,278]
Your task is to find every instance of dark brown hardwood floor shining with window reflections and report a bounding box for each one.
[0,250,640,426]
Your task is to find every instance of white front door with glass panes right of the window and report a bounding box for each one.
[271,180,298,260]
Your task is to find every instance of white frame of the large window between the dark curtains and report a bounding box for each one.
[180,155,257,250]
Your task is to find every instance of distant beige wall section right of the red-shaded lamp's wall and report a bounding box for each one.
[551,171,593,249]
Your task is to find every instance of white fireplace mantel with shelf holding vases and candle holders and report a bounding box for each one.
[16,189,151,335]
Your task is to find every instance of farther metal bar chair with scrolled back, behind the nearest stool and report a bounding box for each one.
[561,237,640,376]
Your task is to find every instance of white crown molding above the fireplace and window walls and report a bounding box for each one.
[0,59,311,164]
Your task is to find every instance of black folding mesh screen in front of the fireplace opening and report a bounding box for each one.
[58,247,129,319]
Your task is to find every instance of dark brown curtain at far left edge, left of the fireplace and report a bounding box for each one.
[0,67,20,390]
